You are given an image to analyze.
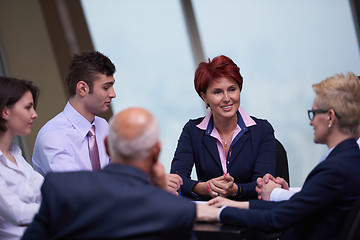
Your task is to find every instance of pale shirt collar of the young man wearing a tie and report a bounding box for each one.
[64,102,97,137]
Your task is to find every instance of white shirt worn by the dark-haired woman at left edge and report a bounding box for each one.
[0,144,44,239]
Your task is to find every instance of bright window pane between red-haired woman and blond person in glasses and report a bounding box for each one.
[192,0,360,186]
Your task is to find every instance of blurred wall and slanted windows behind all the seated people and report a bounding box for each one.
[0,0,360,186]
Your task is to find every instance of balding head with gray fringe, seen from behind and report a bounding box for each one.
[108,108,159,160]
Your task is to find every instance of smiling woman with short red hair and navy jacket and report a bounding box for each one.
[167,56,276,200]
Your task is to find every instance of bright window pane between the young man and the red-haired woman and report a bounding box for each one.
[82,0,205,172]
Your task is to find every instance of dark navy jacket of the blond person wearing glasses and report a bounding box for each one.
[220,139,360,239]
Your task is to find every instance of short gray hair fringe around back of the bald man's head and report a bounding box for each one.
[108,116,160,159]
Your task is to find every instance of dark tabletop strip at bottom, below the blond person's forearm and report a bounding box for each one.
[194,222,280,240]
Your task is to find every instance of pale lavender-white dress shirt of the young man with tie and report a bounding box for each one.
[32,102,110,176]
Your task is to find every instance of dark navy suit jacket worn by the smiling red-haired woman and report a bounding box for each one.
[171,117,276,199]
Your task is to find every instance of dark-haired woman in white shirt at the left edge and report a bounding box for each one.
[0,77,43,239]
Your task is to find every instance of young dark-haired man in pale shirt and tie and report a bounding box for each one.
[32,52,116,175]
